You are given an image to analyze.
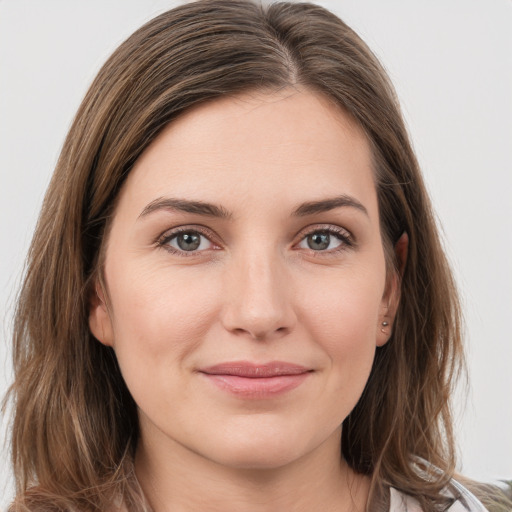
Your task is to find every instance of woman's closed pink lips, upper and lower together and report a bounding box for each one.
[199,361,313,399]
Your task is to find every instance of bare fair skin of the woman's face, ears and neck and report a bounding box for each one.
[90,89,404,512]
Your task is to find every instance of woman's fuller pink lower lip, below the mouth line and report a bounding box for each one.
[202,372,310,399]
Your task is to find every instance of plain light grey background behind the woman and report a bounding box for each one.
[0,0,512,508]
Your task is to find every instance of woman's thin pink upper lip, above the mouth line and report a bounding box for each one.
[199,361,312,379]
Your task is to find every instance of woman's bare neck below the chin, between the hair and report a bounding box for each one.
[135,424,369,512]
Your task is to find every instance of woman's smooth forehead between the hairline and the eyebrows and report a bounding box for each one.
[121,89,376,220]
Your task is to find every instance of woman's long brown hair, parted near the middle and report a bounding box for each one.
[10,0,472,511]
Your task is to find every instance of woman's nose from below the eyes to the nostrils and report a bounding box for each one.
[222,250,296,340]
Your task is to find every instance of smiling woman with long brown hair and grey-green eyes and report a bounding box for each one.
[4,1,508,512]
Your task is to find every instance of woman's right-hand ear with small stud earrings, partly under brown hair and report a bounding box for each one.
[377,231,409,347]
